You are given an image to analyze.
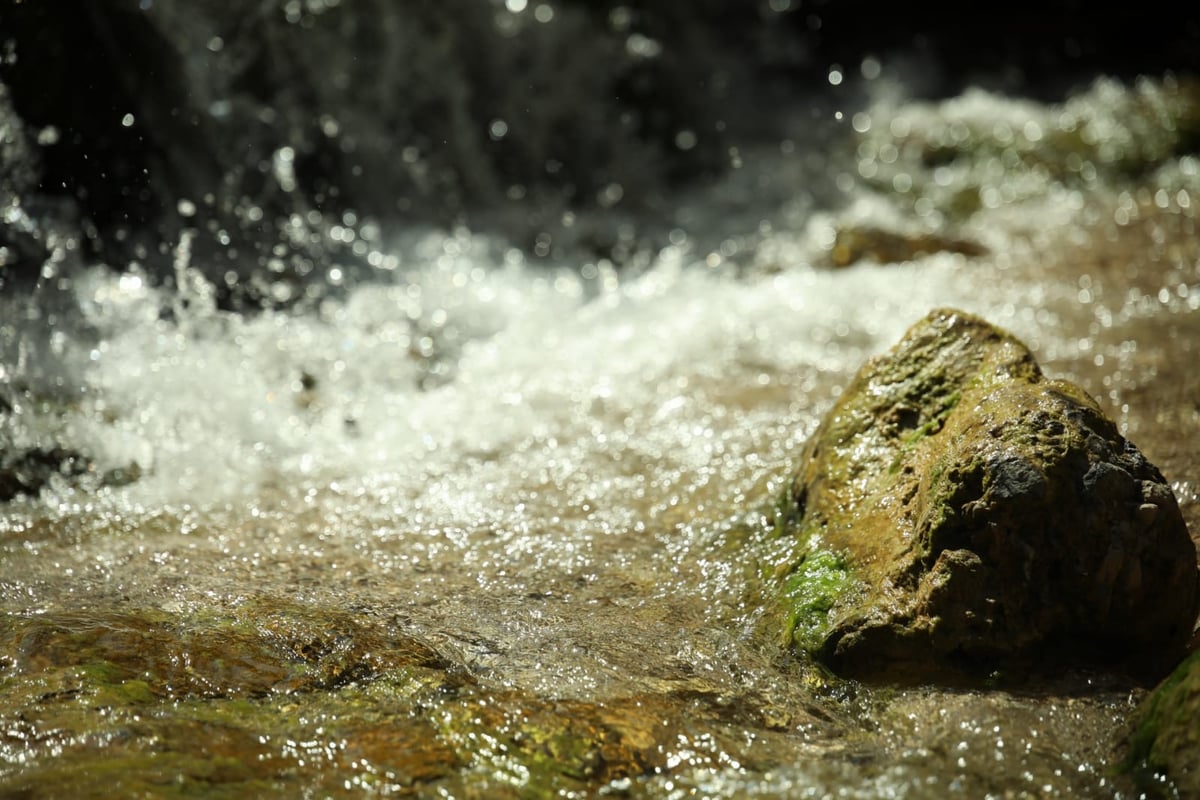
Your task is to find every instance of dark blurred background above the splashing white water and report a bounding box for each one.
[0,0,1200,297]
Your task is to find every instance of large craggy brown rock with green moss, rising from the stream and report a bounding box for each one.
[780,309,1198,681]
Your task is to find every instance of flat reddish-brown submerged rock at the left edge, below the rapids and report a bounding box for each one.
[0,599,452,699]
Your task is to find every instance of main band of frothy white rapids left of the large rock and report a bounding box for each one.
[9,220,1069,530]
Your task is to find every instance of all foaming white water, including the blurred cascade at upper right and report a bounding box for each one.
[4,77,1200,524]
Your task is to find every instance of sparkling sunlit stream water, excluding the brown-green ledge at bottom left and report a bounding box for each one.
[0,77,1200,798]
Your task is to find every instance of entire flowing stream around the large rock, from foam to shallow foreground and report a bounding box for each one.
[0,53,1200,798]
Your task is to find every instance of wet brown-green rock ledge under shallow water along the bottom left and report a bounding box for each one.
[0,597,835,798]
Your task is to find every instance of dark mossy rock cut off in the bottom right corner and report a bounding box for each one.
[1123,651,1200,798]
